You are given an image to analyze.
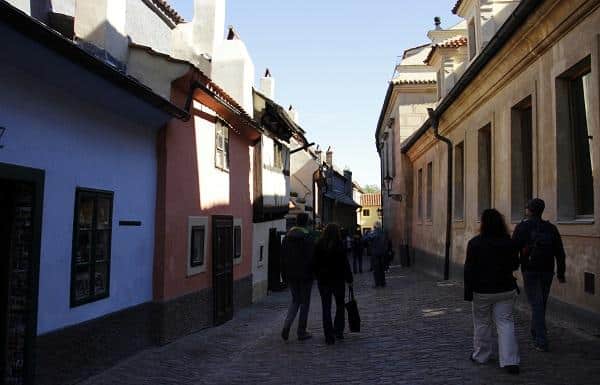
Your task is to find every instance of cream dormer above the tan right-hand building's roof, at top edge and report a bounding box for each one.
[452,0,520,62]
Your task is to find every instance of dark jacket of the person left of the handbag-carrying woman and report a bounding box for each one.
[281,227,314,281]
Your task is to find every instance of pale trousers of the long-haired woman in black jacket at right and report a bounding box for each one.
[471,290,520,368]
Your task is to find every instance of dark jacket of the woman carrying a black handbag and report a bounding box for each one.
[315,240,353,284]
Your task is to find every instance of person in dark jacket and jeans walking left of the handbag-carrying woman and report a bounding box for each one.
[281,213,314,341]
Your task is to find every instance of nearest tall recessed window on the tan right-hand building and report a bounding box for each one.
[556,56,594,220]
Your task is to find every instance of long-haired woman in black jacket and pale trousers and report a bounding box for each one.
[464,209,520,374]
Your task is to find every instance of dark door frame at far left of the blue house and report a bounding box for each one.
[0,162,45,384]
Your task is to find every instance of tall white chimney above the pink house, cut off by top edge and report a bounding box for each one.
[192,0,225,56]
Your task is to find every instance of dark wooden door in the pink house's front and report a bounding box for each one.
[212,216,233,325]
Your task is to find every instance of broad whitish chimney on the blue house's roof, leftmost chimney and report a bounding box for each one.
[74,0,129,69]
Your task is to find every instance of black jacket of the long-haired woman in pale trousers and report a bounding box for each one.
[464,235,519,301]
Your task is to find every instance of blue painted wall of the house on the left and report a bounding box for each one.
[0,65,157,334]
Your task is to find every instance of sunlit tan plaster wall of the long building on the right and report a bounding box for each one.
[409,0,600,312]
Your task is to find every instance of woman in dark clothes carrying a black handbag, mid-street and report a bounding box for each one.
[315,223,353,345]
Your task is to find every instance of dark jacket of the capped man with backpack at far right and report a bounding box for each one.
[513,218,565,278]
